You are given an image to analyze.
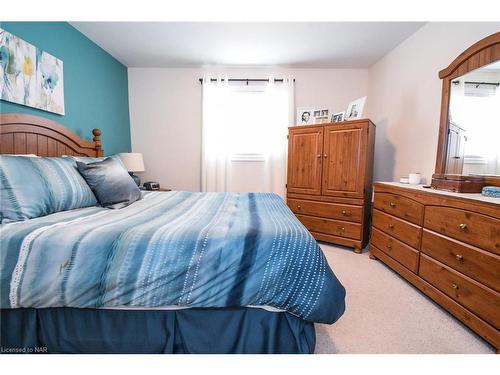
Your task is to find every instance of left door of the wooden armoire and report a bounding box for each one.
[287,126,323,195]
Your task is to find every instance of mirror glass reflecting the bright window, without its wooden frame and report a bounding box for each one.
[446,61,500,175]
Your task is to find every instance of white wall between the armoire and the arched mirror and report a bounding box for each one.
[367,22,500,182]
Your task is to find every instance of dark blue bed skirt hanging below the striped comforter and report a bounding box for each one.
[0,307,316,354]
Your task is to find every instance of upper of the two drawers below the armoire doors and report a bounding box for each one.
[287,199,363,223]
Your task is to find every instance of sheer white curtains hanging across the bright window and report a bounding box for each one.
[202,77,295,197]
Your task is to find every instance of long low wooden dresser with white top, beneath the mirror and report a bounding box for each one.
[370,183,500,350]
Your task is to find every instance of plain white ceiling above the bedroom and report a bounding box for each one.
[71,22,424,68]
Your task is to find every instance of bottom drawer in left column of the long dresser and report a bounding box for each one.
[371,228,418,273]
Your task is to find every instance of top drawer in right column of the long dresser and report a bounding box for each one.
[424,206,500,254]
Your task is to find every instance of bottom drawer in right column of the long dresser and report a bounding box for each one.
[418,254,500,329]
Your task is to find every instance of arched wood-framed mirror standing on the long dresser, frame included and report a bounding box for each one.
[436,32,500,186]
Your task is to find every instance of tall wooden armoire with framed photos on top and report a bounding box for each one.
[286,119,375,253]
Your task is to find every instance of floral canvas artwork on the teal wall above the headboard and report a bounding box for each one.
[0,28,64,115]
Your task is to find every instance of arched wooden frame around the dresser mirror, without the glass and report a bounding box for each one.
[435,32,500,186]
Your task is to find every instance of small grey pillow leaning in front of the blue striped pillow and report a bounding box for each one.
[76,158,142,208]
